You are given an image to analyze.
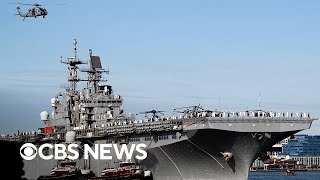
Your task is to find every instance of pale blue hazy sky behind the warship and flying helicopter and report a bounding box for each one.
[0,0,320,134]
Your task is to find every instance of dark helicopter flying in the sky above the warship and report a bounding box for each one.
[10,3,63,20]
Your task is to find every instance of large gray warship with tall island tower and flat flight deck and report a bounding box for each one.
[1,40,316,180]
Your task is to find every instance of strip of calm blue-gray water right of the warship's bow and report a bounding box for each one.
[249,171,320,180]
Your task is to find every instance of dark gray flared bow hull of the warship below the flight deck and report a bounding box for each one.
[142,130,295,180]
